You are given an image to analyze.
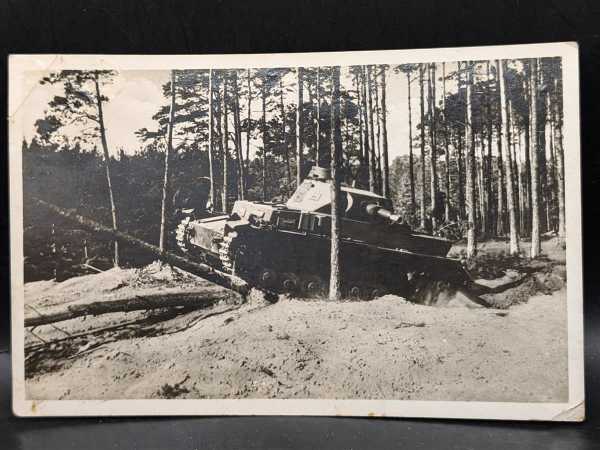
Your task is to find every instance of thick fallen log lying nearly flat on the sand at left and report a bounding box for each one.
[25,291,232,327]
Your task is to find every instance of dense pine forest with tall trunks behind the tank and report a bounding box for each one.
[22,58,565,280]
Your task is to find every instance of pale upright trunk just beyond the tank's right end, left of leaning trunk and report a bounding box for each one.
[465,62,477,258]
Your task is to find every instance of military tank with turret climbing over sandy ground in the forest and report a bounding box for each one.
[176,167,471,299]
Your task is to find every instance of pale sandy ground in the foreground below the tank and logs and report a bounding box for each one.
[26,239,568,402]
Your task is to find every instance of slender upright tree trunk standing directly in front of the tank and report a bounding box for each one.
[329,66,342,300]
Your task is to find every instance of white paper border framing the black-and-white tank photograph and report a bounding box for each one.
[8,42,585,421]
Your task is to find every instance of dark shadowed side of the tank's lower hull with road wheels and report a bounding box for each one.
[230,226,469,297]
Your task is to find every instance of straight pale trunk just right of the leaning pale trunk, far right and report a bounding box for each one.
[530,59,542,258]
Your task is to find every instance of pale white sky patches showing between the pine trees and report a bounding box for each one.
[23,63,456,160]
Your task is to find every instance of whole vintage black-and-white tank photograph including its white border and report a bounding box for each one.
[9,43,584,420]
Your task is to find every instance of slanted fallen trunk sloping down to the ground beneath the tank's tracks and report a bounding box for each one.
[33,198,251,297]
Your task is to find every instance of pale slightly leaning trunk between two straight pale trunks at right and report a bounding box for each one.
[498,61,519,255]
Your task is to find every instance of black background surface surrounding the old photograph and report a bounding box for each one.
[0,0,600,449]
